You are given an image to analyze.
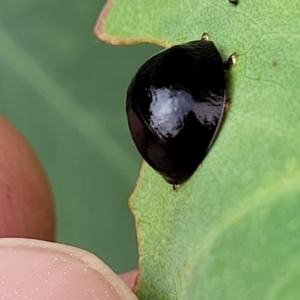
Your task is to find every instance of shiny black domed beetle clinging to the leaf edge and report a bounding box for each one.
[126,34,235,189]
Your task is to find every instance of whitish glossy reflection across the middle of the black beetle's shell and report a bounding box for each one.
[150,88,223,138]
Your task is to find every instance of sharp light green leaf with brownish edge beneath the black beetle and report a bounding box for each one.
[95,0,300,300]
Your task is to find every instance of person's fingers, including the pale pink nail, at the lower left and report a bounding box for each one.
[0,116,137,300]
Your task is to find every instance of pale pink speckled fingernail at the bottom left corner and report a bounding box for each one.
[0,238,137,300]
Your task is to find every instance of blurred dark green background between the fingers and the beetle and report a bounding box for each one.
[0,0,159,272]
